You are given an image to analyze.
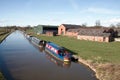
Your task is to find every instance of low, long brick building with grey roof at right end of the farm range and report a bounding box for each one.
[77,28,112,42]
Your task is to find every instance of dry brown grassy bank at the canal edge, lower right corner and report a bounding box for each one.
[78,57,120,80]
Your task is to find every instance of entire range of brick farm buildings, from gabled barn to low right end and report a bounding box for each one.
[58,24,117,42]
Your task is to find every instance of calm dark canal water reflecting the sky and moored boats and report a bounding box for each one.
[0,31,97,80]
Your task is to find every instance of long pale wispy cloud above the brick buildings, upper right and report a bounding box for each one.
[85,7,120,14]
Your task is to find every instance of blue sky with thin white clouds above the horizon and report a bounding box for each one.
[0,0,120,26]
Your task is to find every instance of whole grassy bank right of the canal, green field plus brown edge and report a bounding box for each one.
[26,29,120,80]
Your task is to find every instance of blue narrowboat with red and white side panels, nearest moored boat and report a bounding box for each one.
[45,42,71,62]
